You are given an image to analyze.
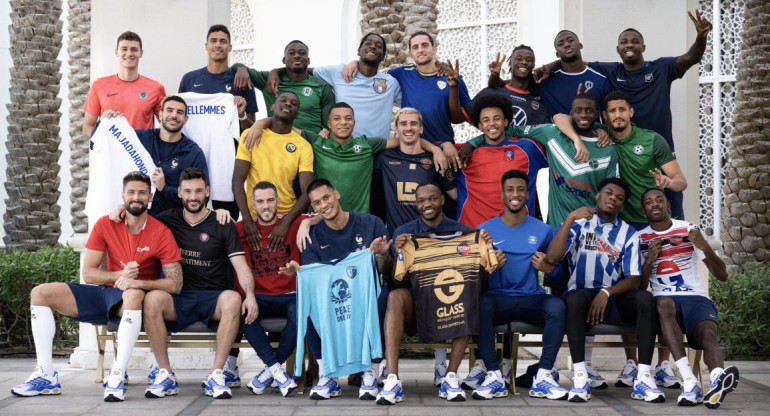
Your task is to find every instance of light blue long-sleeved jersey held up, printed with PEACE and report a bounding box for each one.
[294,250,382,377]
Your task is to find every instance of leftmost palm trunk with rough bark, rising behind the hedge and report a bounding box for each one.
[3,0,62,250]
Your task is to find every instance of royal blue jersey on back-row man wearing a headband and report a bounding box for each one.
[388,65,464,143]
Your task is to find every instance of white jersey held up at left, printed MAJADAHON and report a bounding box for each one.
[86,117,155,228]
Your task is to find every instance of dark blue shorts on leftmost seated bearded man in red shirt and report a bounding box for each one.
[67,282,123,325]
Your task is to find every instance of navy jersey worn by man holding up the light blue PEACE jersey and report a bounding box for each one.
[302,211,388,264]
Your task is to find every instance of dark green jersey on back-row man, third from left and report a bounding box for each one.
[242,68,334,133]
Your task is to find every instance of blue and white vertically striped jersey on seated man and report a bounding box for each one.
[566,211,642,290]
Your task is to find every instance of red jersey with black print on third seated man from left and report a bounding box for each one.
[235,215,309,296]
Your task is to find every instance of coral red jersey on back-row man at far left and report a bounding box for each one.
[83,74,166,130]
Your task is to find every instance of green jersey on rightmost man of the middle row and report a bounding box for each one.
[608,126,676,223]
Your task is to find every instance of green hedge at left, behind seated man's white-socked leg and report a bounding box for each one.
[0,246,80,349]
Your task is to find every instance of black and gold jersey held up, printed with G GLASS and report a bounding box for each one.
[394,230,497,342]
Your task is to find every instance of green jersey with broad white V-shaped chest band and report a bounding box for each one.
[473,124,618,228]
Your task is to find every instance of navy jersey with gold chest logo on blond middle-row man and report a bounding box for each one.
[380,148,457,234]
